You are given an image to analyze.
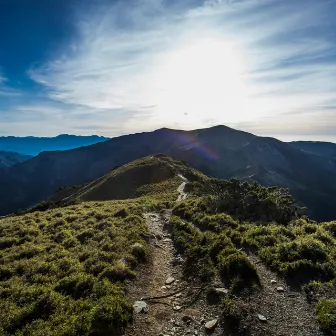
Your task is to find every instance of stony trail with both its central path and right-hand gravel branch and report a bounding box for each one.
[124,176,323,336]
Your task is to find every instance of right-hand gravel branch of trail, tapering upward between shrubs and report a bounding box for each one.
[239,252,324,336]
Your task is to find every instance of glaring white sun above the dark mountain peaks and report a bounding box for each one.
[148,38,253,126]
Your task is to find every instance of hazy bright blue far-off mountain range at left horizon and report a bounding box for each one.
[0,134,109,155]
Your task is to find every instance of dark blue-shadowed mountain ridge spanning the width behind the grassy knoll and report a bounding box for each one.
[0,126,336,220]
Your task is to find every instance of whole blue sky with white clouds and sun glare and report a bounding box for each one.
[0,0,336,142]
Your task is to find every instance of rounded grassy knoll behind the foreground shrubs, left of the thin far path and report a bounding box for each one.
[45,154,208,204]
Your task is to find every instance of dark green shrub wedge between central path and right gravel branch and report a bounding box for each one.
[171,217,259,292]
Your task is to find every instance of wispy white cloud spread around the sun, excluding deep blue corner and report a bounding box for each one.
[0,0,336,141]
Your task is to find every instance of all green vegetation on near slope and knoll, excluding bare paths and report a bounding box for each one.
[0,155,336,336]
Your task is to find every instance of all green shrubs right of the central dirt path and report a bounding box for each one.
[172,180,336,335]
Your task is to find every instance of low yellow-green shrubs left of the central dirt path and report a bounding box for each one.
[0,201,148,335]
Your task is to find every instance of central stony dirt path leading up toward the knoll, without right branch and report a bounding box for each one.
[124,180,223,336]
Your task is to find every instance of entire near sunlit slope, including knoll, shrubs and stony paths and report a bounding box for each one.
[0,154,336,336]
